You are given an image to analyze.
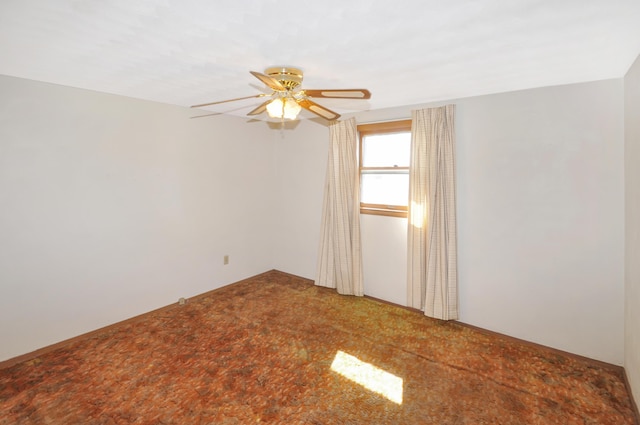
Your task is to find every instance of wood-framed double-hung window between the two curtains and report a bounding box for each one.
[358,120,411,217]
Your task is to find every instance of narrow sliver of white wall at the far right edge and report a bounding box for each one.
[624,56,640,405]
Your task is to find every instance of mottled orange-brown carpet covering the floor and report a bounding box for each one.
[0,271,635,425]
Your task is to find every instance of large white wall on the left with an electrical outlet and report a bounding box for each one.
[0,76,274,360]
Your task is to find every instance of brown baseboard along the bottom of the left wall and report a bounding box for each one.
[0,270,278,369]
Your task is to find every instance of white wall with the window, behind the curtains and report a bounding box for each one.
[277,79,624,365]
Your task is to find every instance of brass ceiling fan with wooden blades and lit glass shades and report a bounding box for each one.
[191,66,371,121]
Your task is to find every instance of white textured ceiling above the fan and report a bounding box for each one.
[0,0,640,120]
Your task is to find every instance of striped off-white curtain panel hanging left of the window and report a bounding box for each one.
[316,118,364,296]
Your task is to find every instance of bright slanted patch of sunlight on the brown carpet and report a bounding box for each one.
[331,351,402,404]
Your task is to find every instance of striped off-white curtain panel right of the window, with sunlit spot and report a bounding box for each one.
[407,105,458,320]
